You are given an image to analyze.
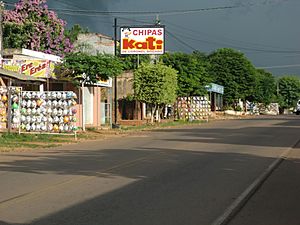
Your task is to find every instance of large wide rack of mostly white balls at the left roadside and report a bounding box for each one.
[21,91,77,133]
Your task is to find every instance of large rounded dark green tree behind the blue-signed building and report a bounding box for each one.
[208,48,256,106]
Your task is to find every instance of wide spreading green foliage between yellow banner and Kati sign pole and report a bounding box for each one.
[58,53,122,85]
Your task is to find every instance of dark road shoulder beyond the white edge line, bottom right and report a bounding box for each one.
[229,145,300,225]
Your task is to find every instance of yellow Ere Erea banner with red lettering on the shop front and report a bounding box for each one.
[2,59,55,78]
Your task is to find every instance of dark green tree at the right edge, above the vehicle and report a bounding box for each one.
[278,76,300,108]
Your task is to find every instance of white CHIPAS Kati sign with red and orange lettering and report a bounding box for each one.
[120,26,165,55]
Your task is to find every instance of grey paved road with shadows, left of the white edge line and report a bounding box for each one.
[0,116,300,225]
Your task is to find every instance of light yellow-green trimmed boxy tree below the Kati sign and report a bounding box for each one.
[133,63,177,123]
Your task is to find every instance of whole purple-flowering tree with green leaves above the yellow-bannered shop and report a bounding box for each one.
[3,0,73,56]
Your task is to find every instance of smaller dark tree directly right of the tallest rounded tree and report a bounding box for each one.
[249,69,276,105]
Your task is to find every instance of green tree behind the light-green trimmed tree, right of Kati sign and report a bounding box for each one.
[161,52,211,96]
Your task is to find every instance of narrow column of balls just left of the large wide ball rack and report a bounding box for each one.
[9,87,22,129]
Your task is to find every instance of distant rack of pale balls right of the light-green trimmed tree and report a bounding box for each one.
[177,96,210,120]
